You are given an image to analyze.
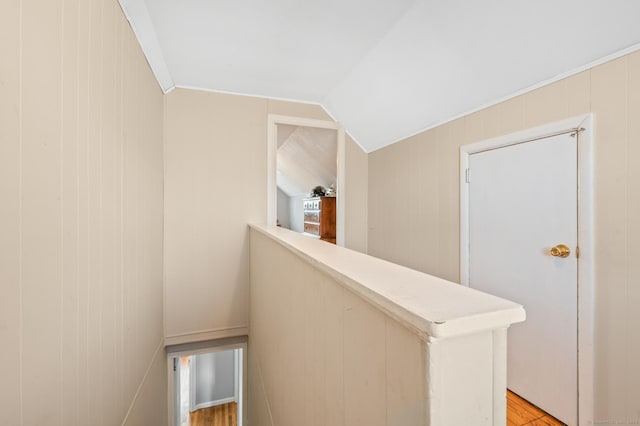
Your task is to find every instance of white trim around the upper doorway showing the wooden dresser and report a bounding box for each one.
[267,114,346,246]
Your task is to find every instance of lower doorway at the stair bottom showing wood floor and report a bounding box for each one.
[167,338,246,426]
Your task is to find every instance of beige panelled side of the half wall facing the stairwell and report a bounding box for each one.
[248,230,424,426]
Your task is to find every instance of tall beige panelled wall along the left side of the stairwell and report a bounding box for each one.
[0,0,166,426]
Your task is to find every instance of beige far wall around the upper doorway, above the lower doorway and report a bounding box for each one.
[165,89,367,343]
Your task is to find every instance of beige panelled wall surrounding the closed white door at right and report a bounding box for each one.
[369,52,640,421]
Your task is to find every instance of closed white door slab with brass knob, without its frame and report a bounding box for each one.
[468,134,578,425]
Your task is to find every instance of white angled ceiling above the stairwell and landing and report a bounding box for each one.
[120,0,640,152]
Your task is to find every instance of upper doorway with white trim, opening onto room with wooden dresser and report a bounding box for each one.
[267,115,345,245]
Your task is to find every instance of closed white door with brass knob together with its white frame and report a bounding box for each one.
[461,116,593,424]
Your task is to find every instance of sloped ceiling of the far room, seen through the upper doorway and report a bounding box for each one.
[276,124,338,197]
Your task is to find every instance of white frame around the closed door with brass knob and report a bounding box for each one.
[460,113,594,424]
